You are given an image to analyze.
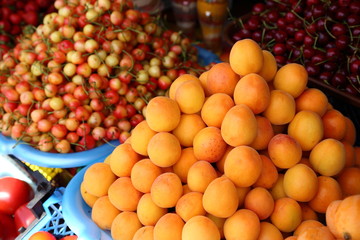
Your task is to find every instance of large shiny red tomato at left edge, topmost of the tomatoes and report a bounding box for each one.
[0,177,34,215]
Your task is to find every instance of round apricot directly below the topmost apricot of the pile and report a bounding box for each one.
[234,73,270,114]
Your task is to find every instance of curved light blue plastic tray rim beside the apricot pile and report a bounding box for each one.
[62,162,112,240]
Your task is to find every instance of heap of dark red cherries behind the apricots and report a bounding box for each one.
[225,0,360,107]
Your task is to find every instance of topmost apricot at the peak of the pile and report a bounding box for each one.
[229,39,264,76]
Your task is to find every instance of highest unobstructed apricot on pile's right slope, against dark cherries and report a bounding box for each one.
[273,63,308,98]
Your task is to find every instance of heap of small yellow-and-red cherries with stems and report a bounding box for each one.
[0,0,211,169]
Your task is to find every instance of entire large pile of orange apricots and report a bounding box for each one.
[77,39,360,240]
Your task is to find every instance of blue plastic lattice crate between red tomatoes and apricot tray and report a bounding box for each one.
[20,187,74,240]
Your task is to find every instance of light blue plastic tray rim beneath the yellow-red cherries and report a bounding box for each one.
[0,134,120,168]
